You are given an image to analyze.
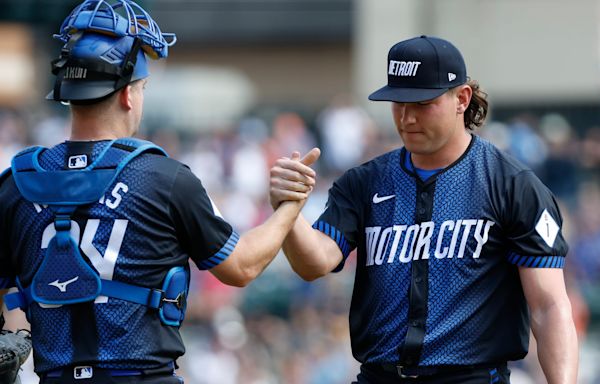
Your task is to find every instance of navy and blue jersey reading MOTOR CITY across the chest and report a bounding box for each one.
[313,136,567,366]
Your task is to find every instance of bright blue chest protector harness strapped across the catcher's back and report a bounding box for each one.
[5,138,189,325]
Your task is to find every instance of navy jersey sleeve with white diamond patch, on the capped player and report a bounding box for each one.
[506,171,568,268]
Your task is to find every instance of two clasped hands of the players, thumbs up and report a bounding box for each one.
[269,148,321,209]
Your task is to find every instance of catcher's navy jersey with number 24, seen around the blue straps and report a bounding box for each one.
[0,141,238,373]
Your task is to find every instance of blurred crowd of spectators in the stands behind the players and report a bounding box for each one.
[0,95,600,384]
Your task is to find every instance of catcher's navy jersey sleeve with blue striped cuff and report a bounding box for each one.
[170,165,239,270]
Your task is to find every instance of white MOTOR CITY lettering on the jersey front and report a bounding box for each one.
[365,219,495,267]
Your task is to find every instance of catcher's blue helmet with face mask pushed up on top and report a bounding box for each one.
[46,0,177,101]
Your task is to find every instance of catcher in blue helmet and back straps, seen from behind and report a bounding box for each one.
[0,0,319,384]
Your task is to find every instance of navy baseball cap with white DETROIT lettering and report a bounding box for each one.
[369,36,467,103]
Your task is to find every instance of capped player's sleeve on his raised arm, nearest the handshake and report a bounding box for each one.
[313,169,364,272]
